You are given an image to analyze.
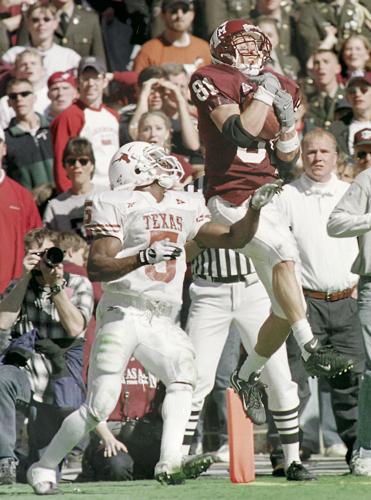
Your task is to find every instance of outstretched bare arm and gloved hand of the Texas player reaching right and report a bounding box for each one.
[195,180,282,248]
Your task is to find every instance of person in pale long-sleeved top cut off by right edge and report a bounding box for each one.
[327,148,371,476]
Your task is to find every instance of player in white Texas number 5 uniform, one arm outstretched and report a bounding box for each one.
[28,142,280,495]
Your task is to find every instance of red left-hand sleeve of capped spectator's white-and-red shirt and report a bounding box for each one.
[51,107,84,192]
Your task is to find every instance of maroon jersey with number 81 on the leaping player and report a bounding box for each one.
[190,64,299,205]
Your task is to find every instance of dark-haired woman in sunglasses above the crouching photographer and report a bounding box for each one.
[43,137,103,238]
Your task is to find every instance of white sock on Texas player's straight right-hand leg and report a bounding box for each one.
[160,383,193,463]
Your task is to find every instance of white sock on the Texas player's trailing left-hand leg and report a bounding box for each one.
[39,405,98,469]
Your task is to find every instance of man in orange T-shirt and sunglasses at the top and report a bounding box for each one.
[133,0,211,73]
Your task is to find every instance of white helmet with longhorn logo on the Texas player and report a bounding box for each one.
[108,141,184,190]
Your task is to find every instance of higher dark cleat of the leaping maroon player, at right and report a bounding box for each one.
[303,342,353,378]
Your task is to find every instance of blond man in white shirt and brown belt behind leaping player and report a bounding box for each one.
[275,128,364,463]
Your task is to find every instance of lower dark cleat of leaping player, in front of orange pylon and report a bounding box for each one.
[230,370,267,425]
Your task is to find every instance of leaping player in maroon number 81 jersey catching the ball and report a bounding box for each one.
[190,19,351,421]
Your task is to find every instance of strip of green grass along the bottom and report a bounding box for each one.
[0,475,371,500]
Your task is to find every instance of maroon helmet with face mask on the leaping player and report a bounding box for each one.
[210,19,272,76]
